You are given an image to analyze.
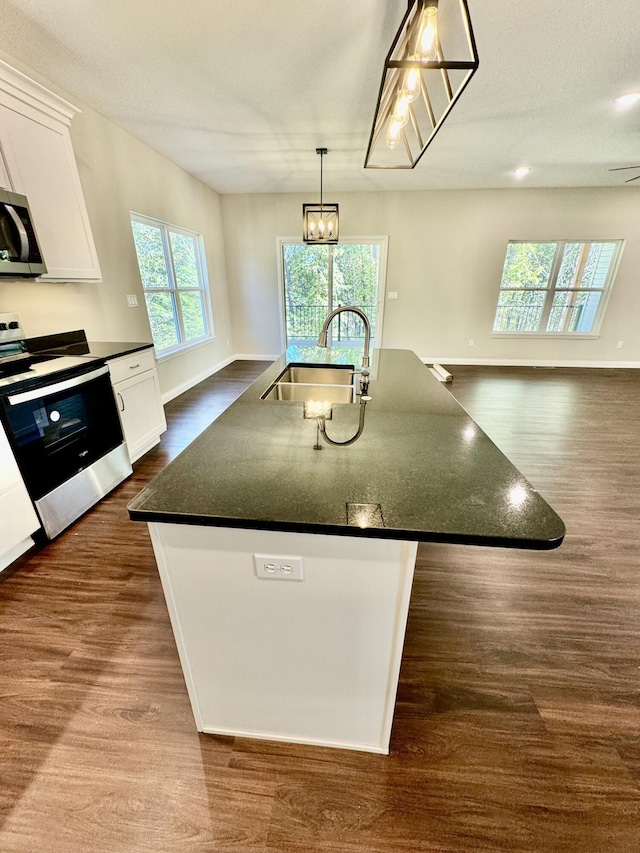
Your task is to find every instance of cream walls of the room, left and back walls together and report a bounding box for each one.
[0,51,640,397]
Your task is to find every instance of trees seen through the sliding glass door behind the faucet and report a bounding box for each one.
[282,243,380,346]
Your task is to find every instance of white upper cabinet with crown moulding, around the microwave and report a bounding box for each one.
[0,61,101,281]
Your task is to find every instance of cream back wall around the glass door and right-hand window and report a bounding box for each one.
[222,187,640,366]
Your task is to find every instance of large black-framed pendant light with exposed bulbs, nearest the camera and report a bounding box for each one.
[364,0,478,169]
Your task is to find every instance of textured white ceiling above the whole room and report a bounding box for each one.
[0,0,640,193]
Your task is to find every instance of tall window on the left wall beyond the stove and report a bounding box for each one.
[131,213,213,355]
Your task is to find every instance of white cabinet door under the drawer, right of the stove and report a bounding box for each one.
[113,369,167,462]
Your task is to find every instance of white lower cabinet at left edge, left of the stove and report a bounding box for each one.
[0,424,40,571]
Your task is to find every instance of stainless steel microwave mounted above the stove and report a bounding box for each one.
[0,190,47,278]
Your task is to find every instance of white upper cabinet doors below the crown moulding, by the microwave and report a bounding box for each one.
[0,104,100,281]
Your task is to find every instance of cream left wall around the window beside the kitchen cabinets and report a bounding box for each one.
[0,54,234,397]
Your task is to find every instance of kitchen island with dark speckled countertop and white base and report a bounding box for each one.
[129,350,564,753]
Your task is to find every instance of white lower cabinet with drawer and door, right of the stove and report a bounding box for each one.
[109,348,167,462]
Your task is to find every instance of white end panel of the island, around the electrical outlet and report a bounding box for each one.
[149,523,417,753]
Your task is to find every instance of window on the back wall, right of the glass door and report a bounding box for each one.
[493,240,622,334]
